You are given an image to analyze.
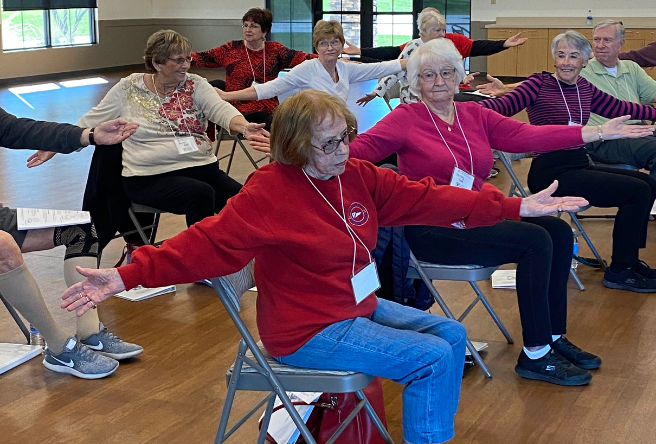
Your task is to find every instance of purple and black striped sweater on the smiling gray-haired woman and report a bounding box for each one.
[477,72,656,154]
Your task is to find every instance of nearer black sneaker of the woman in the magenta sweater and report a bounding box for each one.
[515,349,592,385]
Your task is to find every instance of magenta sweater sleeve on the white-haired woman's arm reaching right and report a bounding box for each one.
[481,108,585,153]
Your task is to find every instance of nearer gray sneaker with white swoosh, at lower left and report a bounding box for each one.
[43,336,118,379]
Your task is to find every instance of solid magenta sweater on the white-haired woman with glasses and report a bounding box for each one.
[349,102,583,190]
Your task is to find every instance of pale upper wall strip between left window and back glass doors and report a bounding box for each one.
[151,0,266,20]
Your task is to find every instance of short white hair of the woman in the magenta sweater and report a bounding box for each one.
[407,38,465,99]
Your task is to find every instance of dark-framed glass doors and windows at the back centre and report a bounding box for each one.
[266,0,471,52]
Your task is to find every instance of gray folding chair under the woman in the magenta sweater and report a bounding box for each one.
[408,251,514,378]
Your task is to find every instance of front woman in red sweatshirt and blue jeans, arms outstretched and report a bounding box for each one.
[62,90,585,443]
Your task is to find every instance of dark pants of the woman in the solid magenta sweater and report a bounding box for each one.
[405,217,574,347]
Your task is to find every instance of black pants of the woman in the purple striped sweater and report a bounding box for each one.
[528,148,656,265]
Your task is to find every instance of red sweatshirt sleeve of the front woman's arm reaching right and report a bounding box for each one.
[359,162,521,227]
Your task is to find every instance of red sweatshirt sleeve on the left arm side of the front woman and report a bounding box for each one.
[118,190,272,290]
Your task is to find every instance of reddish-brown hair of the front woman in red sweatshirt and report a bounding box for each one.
[270,89,357,166]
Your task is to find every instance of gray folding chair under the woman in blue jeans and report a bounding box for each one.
[211,262,394,444]
